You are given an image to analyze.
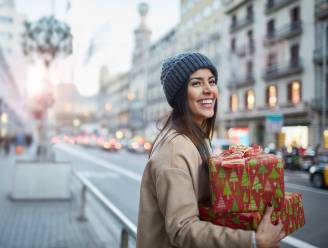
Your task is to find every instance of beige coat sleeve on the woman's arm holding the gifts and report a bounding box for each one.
[155,139,252,248]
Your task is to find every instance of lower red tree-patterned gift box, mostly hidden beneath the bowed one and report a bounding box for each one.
[199,192,305,235]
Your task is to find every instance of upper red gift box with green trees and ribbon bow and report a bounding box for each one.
[209,145,285,213]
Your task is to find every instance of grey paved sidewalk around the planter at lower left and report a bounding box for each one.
[0,151,117,248]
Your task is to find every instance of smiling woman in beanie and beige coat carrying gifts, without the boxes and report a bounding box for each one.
[137,52,284,248]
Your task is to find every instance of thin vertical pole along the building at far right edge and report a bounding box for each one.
[321,24,328,145]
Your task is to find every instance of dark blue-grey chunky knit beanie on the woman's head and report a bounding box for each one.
[161,52,218,108]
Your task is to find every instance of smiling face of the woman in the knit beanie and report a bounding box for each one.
[188,68,218,126]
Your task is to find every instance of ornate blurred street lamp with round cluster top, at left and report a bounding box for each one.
[22,16,72,161]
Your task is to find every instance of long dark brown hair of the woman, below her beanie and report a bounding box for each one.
[149,76,217,166]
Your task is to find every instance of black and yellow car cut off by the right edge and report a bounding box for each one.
[309,153,328,188]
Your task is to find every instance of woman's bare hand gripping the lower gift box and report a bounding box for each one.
[255,207,285,248]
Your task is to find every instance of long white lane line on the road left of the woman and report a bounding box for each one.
[56,145,141,182]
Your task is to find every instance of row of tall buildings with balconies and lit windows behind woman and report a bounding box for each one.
[98,0,328,147]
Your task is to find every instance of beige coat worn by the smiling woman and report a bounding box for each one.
[137,131,252,248]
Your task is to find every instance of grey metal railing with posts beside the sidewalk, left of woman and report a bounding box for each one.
[73,171,137,248]
